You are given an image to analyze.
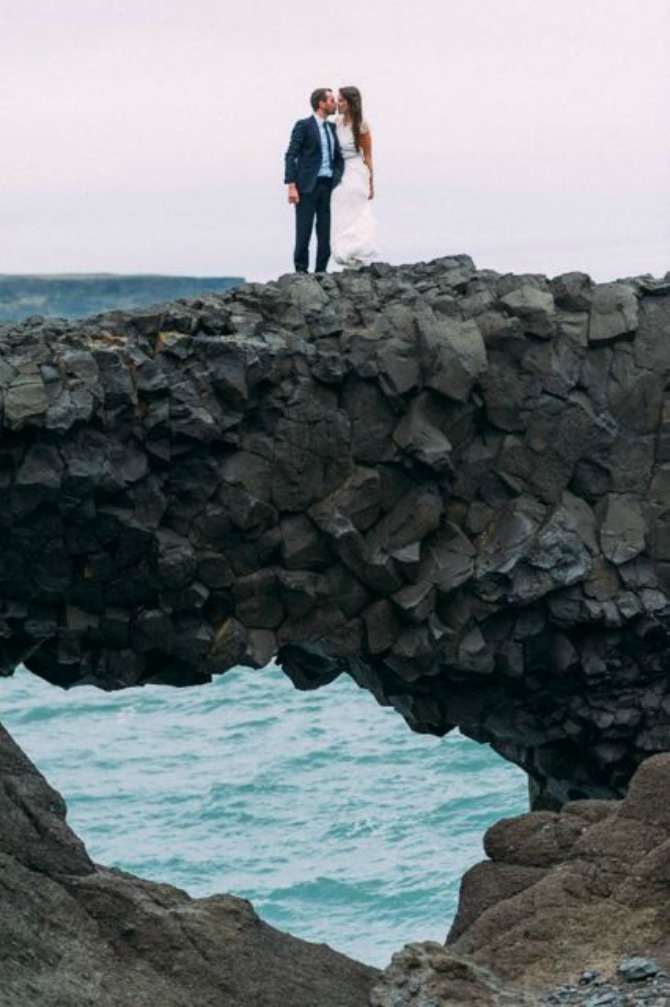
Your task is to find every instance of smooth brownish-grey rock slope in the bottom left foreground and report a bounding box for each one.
[0,727,377,1007]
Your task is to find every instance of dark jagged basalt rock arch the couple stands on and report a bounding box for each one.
[0,256,670,807]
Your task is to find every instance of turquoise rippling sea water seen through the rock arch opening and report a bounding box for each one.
[0,667,527,966]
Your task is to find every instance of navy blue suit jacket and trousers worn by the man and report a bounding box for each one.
[284,116,345,273]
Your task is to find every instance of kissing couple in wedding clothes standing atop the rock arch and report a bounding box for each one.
[284,88,378,273]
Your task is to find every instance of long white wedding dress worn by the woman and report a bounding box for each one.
[330,116,379,266]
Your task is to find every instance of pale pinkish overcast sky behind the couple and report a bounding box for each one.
[0,0,670,280]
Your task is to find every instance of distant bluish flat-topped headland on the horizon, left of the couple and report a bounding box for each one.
[0,273,243,321]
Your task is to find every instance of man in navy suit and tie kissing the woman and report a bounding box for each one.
[284,88,345,273]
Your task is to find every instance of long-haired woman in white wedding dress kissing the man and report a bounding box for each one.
[330,88,379,267]
